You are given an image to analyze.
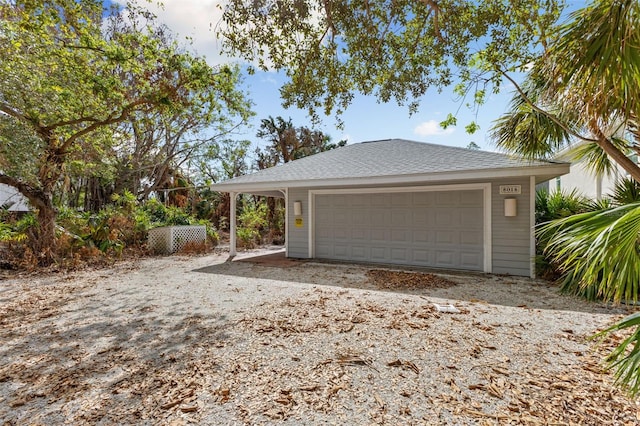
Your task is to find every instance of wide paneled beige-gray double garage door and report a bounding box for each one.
[314,190,484,271]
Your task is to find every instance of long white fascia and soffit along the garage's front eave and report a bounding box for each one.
[211,163,570,198]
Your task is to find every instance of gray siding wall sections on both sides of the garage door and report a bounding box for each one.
[287,177,531,276]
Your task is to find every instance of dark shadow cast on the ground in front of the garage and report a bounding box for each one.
[193,252,627,314]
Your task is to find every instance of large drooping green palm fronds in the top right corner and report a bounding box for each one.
[550,0,640,123]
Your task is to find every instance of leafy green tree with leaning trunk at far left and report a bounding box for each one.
[0,0,250,263]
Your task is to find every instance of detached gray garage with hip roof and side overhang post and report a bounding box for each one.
[212,139,569,277]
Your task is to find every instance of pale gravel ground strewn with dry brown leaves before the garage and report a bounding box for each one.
[0,251,640,425]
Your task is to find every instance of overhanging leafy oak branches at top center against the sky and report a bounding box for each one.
[219,0,562,123]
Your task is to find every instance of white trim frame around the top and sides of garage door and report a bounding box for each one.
[308,183,493,273]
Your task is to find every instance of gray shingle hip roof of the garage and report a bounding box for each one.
[213,139,568,190]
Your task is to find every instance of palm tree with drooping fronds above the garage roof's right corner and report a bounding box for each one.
[492,0,640,181]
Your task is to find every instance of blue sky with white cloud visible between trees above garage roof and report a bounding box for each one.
[116,0,586,151]
